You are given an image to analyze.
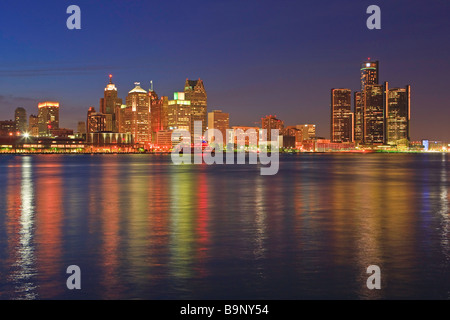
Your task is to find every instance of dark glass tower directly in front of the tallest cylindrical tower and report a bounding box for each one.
[363,84,386,145]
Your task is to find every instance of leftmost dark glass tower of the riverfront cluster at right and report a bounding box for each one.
[330,89,354,142]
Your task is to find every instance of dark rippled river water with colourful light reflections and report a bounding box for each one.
[0,154,450,299]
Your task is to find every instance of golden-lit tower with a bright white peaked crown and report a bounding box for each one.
[125,82,151,143]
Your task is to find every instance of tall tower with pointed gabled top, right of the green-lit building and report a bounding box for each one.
[184,79,208,135]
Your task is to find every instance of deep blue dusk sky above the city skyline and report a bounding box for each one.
[0,0,450,141]
